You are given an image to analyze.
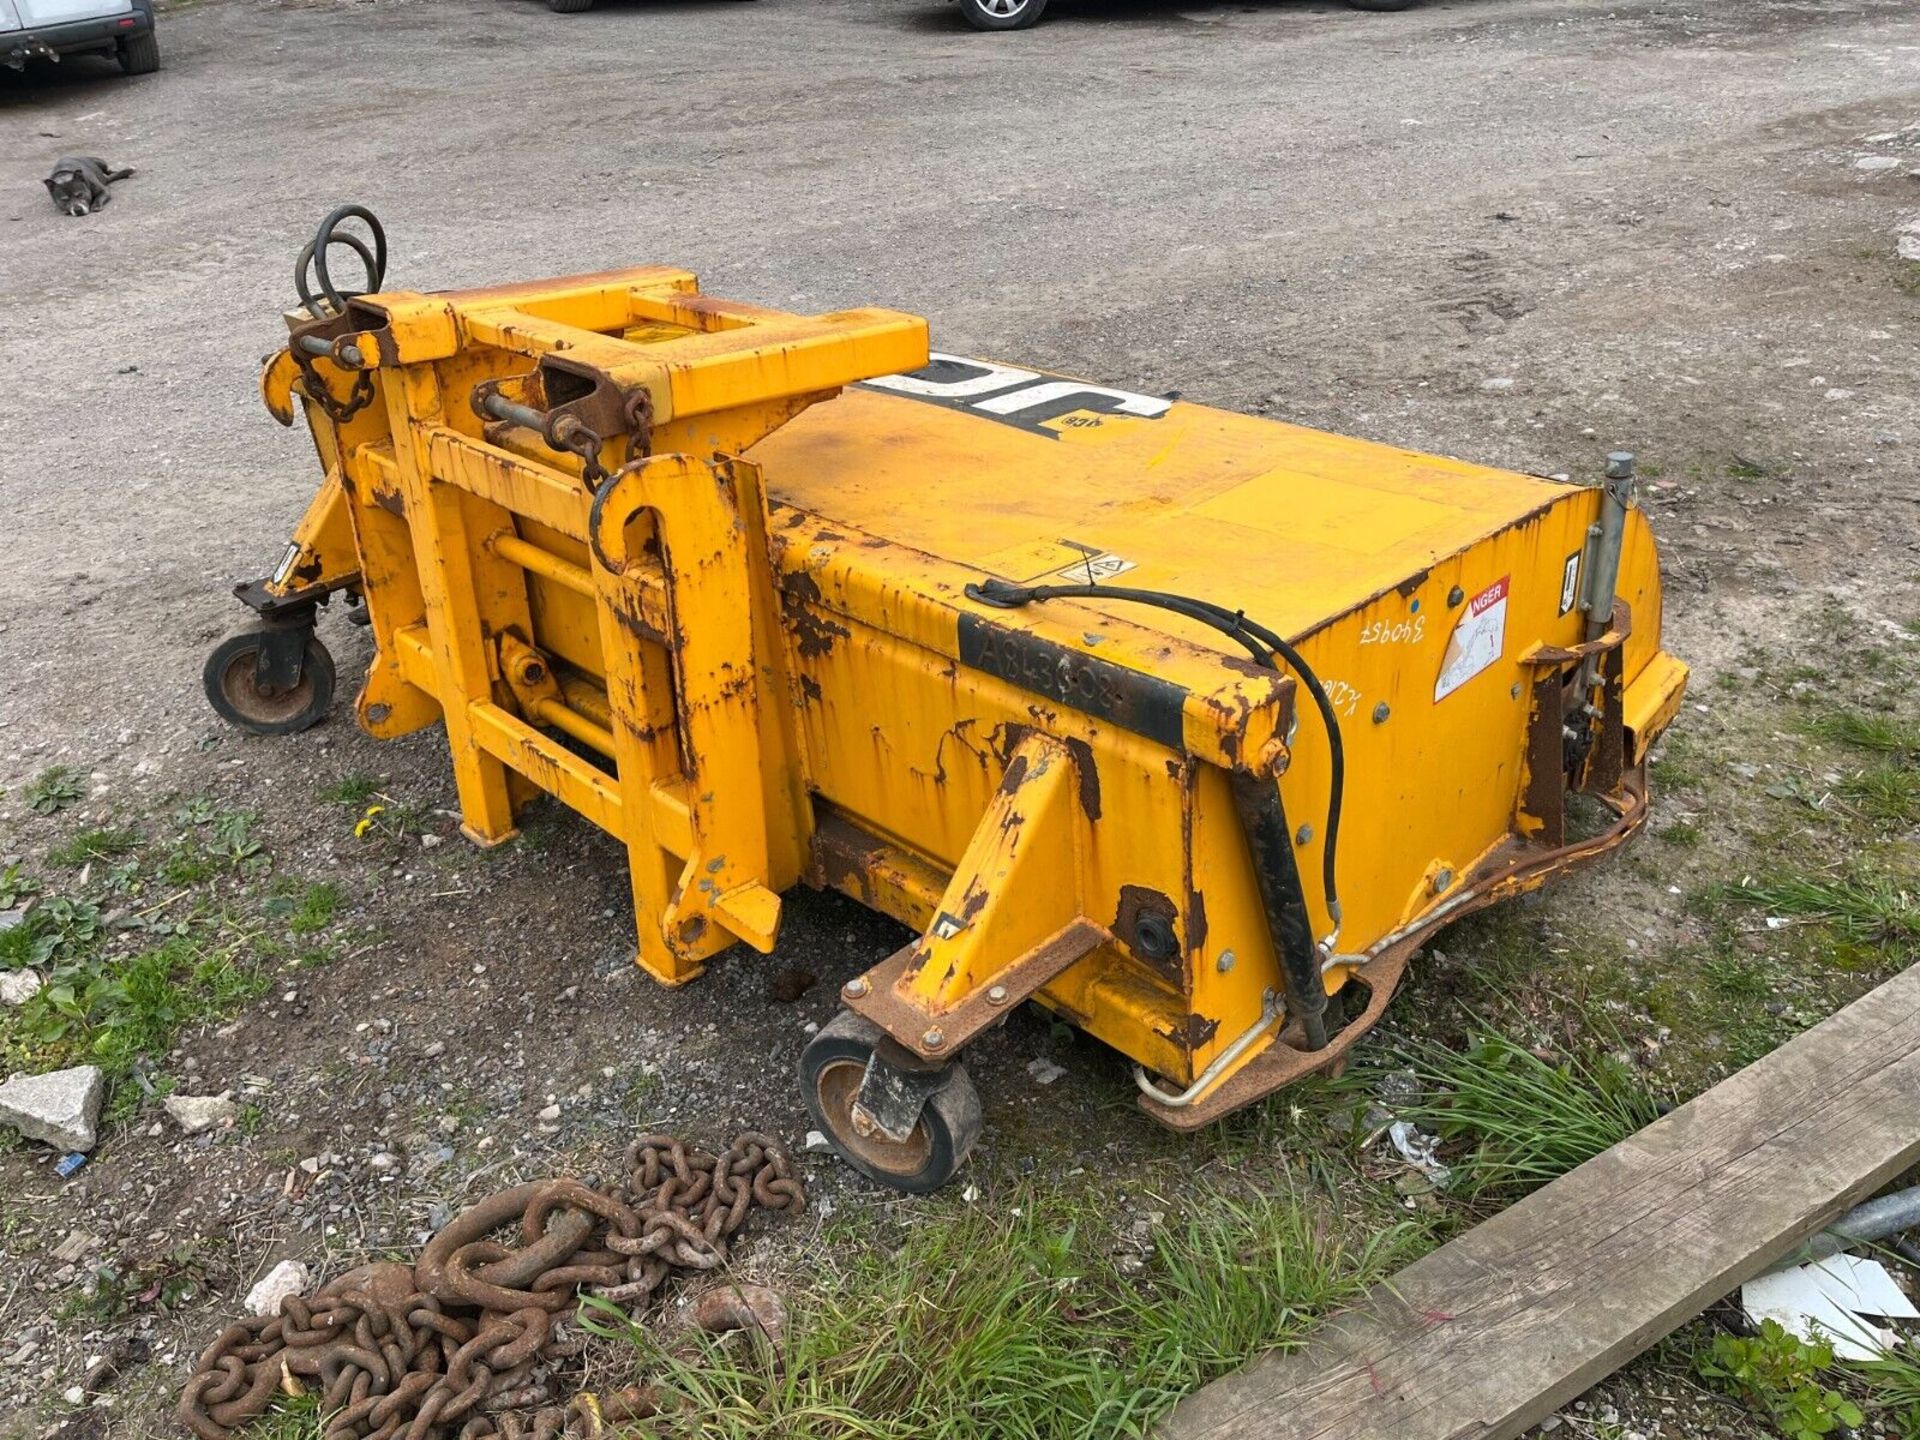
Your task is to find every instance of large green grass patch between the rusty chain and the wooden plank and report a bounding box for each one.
[588,1185,1415,1440]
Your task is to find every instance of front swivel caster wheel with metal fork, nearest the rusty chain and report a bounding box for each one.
[801,1012,981,1194]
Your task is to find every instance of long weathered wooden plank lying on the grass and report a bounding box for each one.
[1160,966,1920,1440]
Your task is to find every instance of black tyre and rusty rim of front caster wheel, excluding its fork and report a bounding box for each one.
[801,1012,981,1194]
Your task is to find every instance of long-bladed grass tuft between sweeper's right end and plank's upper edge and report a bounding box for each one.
[1367,1031,1661,1198]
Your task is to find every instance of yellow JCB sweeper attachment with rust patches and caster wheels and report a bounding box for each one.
[207,208,1686,1190]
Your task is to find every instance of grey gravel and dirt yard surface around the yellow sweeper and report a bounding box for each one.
[0,0,1920,1436]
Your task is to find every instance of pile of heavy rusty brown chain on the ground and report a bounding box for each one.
[177,1131,806,1440]
